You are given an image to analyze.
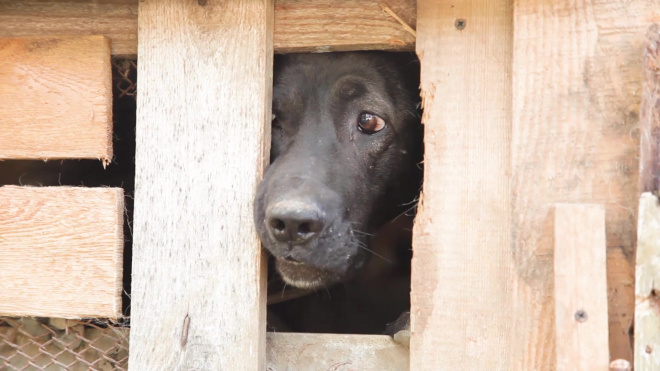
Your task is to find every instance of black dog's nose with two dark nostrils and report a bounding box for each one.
[266,201,325,245]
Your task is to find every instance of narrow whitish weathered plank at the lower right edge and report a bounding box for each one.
[635,193,660,371]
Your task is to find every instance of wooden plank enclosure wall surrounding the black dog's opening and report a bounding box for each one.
[0,0,660,370]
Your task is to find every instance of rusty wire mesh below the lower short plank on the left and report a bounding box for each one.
[0,317,129,371]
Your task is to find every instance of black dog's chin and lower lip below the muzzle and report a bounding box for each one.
[275,259,341,289]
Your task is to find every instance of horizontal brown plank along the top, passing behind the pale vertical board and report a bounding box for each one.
[0,0,416,55]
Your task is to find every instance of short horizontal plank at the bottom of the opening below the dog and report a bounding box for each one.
[266,332,410,371]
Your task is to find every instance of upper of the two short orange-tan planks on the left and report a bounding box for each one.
[0,36,112,163]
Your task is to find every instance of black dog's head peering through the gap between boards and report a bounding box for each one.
[254,52,422,288]
